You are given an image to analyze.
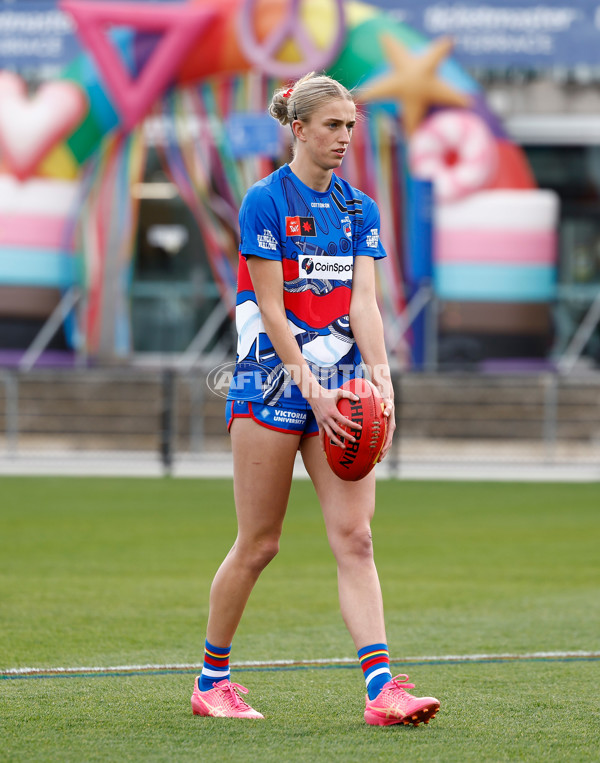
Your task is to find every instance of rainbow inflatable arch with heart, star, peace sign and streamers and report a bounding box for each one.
[0,0,558,364]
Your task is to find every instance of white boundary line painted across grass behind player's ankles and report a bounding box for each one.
[0,651,600,676]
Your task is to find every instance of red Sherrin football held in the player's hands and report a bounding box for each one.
[325,379,387,482]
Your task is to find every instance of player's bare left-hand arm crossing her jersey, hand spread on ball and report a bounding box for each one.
[247,256,360,448]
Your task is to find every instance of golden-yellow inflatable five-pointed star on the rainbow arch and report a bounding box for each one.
[361,34,469,137]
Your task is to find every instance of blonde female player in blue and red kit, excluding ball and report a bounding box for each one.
[192,73,439,725]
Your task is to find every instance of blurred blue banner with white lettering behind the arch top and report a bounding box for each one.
[0,0,600,70]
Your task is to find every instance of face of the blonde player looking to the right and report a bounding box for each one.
[302,98,356,170]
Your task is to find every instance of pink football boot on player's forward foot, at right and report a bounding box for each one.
[365,675,440,726]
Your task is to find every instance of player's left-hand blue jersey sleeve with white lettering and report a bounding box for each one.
[239,186,282,262]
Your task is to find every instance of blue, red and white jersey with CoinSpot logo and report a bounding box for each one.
[228,164,386,408]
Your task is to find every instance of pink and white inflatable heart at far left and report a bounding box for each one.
[0,72,88,180]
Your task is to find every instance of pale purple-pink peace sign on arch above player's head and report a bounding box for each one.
[237,0,346,79]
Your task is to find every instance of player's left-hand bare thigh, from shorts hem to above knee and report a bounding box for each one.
[230,418,300,537]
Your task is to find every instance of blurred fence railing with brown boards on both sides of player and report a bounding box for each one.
[0,366,600,468]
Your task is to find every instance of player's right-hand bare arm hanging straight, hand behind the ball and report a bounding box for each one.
[350,255,396,461]
